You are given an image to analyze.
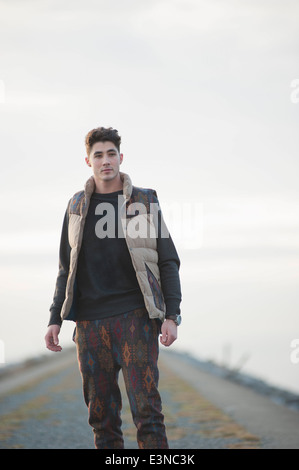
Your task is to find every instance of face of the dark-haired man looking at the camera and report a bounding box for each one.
[85,141,123,181]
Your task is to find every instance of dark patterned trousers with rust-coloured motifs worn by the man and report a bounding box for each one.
[76,308,168,449]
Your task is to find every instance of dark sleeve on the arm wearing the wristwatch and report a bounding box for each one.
[154,192,182,317]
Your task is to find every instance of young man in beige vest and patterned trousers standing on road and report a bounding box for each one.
[45,127,181,449]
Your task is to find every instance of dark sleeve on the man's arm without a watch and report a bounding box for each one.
[48,206,71,326]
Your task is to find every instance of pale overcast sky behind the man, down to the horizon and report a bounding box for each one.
[0,0,299,390]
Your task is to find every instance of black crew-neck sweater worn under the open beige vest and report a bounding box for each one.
[49,191,181,325]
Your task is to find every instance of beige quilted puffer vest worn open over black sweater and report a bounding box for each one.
[61,173,166,321]
